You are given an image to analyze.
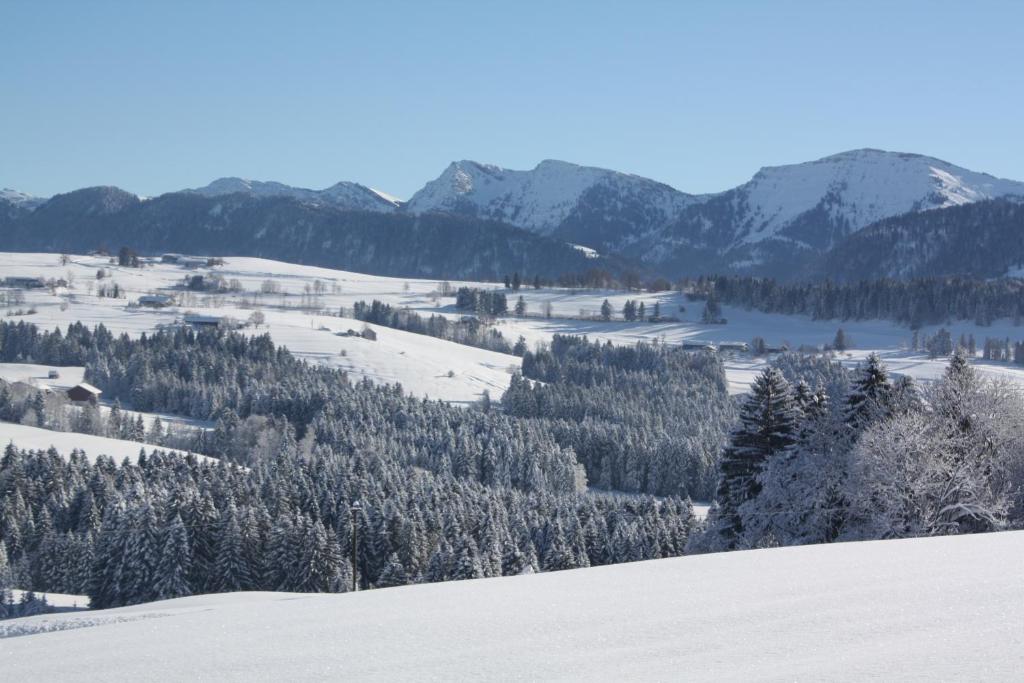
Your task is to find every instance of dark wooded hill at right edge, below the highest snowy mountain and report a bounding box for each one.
[814,199,1024,281]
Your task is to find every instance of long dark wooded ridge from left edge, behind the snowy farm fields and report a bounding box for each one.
[0,187,606,279]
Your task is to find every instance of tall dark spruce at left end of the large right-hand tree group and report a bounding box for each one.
[707,368,801,550]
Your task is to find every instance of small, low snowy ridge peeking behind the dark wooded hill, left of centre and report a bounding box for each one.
[185,177,400,212]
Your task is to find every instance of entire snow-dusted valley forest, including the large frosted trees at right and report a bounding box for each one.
[0,322,1024,615]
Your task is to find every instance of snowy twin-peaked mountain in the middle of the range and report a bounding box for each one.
[406,160,693,249]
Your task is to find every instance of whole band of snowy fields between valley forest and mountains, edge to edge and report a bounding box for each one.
[0,253,1024,403]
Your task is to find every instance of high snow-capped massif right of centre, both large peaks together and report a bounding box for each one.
[406,150,1024,273]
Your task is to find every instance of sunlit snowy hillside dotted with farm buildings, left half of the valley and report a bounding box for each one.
[0,253,519,403]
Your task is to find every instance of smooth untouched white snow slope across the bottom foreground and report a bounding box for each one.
[0,532,1024,681]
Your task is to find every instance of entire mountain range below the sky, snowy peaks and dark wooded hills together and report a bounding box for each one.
[6,150,1024,279]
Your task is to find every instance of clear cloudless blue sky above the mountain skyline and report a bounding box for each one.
[0,0,1024,198]
